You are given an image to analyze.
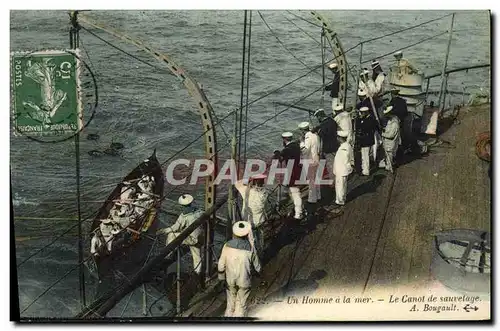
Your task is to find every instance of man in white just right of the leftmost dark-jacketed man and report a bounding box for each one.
[299,122,321,204]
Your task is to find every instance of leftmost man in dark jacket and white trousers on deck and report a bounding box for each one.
[273,132,303,220]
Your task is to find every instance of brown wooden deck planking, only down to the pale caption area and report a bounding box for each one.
[187,106,491,316]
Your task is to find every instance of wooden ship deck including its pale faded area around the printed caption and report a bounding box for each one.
[184,105,491,320]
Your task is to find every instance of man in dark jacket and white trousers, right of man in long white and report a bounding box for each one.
[356,107,377,176]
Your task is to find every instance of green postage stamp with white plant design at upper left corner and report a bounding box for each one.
[11,50,82,136]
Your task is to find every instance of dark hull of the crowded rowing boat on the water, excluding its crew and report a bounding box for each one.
[89,152,165,279]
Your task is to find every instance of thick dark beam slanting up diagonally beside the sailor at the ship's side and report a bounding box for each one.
[76,195,227,319]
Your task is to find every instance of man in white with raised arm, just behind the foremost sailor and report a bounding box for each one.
[234,174,269,252]
